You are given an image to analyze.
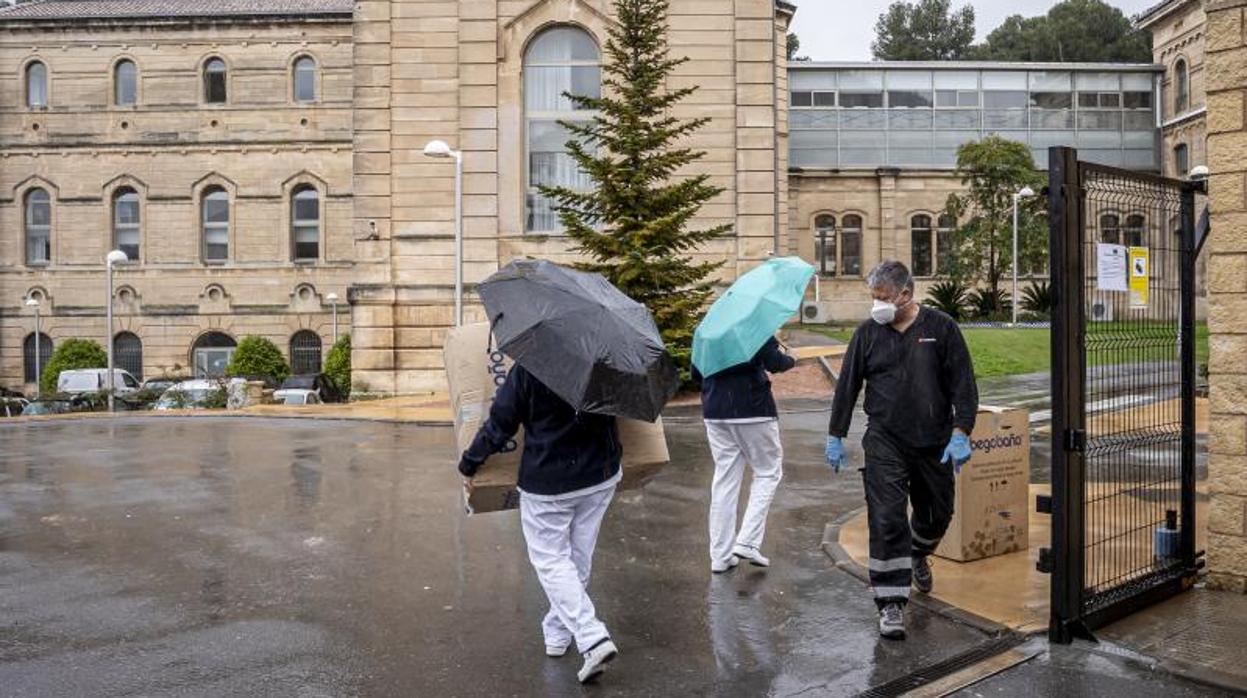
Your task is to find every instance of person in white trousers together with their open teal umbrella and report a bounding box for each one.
[692,257,814,573]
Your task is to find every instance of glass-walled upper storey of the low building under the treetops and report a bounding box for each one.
[789,62,1163,171]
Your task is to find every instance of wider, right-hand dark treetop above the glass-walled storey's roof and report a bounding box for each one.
[970,0,1152,64]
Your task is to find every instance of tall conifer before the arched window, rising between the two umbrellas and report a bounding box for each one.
[541,0,732,370]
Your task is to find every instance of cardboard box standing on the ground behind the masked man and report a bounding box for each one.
[935,406,1030,562]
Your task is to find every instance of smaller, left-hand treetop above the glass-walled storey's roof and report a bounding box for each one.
[870,0,974,61]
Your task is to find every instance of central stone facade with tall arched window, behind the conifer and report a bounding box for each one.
[350,0,794,393]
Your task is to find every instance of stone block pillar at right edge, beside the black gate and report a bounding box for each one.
[1206,0,1247,592]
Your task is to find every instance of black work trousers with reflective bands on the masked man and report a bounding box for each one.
[862,429,955,608]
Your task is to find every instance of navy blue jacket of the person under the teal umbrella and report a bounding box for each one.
[693,337,797,419]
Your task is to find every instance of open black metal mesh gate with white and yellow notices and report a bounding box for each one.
[1040,148,1201,642]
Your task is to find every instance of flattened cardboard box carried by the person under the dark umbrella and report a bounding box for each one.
[445,323,671,514]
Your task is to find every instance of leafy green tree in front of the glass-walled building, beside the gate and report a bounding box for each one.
[944,136,1047,310]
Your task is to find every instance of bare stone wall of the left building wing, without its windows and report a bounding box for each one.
[0,17,369,388]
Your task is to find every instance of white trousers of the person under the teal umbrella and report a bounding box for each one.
[706,420,783,563]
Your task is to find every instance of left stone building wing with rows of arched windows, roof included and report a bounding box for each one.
[0,0,361,389]
